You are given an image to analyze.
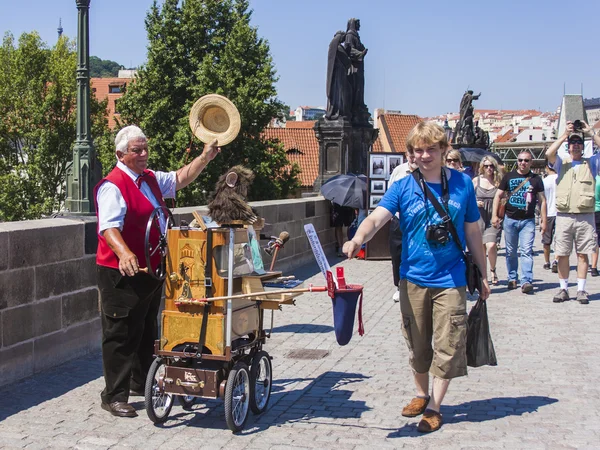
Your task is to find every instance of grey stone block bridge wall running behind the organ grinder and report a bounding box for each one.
[0,197,335,386]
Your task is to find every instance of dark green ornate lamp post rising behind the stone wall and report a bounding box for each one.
[65,0,102,215]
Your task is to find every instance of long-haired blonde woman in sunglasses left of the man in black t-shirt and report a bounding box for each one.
[473,156,502,285]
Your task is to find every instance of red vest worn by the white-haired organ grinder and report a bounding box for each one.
[94,167,166,269]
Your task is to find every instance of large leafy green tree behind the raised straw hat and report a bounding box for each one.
[119,0,299,205]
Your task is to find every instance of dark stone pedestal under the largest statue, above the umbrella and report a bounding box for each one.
[314,118,379,192]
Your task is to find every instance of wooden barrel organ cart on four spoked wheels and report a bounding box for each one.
[145,208,300,432]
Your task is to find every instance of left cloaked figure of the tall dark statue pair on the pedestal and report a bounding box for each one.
[325,31,352,120]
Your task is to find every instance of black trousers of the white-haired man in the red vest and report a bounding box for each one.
[97,266,163,403]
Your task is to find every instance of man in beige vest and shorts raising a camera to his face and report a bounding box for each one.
[546,120,600,305]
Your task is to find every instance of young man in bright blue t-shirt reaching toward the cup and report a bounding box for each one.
[343,122,490,432]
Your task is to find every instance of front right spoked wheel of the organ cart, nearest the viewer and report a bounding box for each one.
[225,361,250,433]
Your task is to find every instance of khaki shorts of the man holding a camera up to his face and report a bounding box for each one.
[554,213,598,256]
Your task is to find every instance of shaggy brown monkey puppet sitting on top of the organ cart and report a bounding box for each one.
[208,166,257,224]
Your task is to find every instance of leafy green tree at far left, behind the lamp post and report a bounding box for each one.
[0,32,113,221]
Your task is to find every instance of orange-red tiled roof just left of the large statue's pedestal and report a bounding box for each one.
[262,127,319,187]
